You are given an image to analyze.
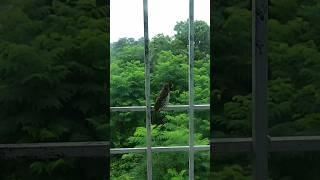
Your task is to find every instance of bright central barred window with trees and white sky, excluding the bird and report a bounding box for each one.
[111,0,210,179]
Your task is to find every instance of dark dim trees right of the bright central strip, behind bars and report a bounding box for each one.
[211,0,320,180]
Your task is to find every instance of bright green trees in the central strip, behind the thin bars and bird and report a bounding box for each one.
[111,17,210,180]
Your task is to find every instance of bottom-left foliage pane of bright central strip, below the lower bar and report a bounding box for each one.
[110,153,147,180]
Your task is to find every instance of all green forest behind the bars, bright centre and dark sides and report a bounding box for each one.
[0,0,320,180]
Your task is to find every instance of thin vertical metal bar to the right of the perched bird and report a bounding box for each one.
[189,0,194,180]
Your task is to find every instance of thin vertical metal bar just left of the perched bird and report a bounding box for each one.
[143,0,152,180]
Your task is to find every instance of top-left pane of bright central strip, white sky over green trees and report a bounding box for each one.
[110,0,145,106]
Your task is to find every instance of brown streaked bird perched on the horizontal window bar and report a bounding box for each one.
[152,81,173,124]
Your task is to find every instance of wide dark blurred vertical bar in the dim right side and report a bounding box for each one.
[252,0,268,180]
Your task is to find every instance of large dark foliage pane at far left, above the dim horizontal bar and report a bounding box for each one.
[0,0,109,143]
